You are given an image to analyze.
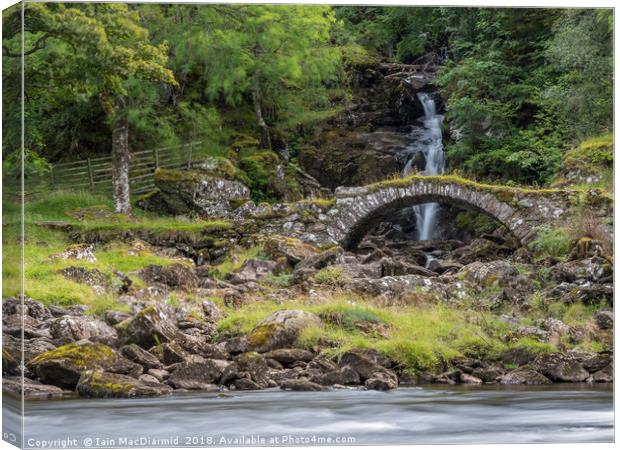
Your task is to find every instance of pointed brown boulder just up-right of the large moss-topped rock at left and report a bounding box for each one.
[116,305,179,348]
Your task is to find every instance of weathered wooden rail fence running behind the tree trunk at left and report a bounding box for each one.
[3,141,202,194]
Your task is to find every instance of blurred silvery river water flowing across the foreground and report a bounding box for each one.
[3,384,614,447]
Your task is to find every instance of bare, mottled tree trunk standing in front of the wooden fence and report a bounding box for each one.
[112,109,131,214]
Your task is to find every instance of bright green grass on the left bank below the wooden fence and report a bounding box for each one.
[2,191,208,313]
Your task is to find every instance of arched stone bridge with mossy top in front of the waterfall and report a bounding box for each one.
[273,175,572,248]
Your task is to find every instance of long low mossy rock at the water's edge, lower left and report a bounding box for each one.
[77,370,172,398]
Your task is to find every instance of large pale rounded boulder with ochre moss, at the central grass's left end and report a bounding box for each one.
[247,310,322,352]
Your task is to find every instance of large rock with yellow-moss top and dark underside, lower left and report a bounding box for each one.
[28,341,142,389]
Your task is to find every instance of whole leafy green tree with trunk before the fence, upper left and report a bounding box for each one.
[2,3,176,214]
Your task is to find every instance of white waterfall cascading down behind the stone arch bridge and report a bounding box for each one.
[403,92,445,241]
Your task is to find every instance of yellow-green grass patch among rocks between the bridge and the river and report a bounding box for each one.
[218,294,554,373]
